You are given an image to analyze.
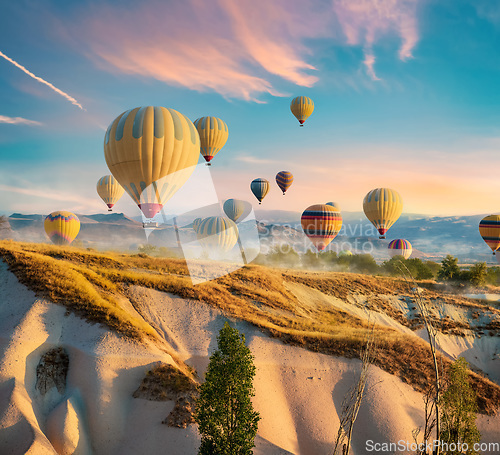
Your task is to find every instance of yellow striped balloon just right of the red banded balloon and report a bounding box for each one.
[363,188,403,239]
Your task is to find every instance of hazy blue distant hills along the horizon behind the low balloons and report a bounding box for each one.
[4,210,496,264]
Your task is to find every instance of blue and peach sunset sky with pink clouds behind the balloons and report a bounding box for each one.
[0,0,500,220]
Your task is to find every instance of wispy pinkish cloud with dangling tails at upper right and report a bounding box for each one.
[333,0,421,80]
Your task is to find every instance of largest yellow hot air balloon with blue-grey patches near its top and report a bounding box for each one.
[104,106,200,218]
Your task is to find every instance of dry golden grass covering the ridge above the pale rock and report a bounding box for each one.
[0,241,500,413]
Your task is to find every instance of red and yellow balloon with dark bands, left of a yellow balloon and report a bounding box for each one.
[300,204,342,251]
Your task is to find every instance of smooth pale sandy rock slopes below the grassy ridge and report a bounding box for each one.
[0,263,500,455]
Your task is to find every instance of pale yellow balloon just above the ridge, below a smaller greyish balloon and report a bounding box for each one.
[196,216,238,257]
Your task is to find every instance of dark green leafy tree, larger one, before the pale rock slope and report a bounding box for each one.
[195,322,260,455]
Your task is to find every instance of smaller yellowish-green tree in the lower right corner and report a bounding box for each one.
[439,357,481,455]
